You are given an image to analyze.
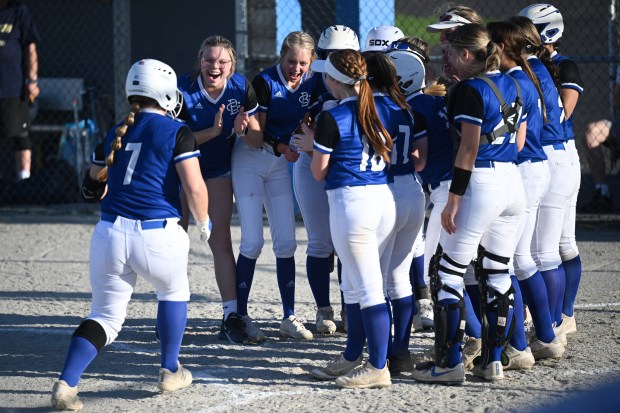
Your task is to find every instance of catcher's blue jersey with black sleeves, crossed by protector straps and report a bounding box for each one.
[448,71,521,163]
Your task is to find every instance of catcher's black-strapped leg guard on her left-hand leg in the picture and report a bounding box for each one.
[429,245,467,367]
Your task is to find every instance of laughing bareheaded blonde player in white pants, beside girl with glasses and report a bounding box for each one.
[232,32,320,341]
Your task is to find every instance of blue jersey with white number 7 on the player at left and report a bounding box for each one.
[101,111,200,220]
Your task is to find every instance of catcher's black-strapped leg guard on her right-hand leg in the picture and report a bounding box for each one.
[474,245,514,366]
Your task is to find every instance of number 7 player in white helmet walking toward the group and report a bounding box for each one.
[52,59,209,410]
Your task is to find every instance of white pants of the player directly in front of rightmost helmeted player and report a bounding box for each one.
[532,143,580,271]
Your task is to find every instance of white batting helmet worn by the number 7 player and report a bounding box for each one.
[125,59,183,118]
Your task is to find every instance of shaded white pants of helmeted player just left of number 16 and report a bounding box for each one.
[293,153,334,258]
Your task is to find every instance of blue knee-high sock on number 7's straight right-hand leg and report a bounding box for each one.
[157,301,187,373]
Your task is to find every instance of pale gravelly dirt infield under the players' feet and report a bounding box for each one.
[0,206,620,412]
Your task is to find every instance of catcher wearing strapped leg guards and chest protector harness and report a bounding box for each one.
[413,24,526,384]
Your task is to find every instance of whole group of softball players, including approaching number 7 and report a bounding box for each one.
[52,4,583,410]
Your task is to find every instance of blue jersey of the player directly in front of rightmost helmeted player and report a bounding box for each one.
[527,56,564,146]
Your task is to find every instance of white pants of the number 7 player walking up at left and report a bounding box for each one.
[88,217,190,345]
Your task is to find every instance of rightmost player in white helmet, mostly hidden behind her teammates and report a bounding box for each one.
[519,4,583,334]
